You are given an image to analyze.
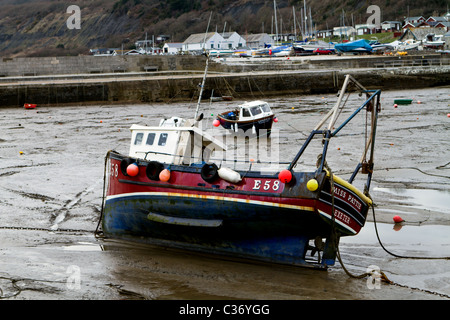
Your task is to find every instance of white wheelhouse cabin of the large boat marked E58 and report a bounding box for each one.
[129,119,226,165]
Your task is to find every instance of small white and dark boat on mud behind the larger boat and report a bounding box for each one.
[213,100,277,136]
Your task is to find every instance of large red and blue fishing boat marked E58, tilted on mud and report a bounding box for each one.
[98,75,381,269]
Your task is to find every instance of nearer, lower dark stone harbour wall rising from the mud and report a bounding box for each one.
[0,56,450,107]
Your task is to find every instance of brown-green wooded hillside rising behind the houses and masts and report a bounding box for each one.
[0,0,449,57]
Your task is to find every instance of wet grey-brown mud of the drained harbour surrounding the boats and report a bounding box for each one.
[0,87,450,300]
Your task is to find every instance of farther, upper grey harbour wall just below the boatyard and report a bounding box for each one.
[0,53,450,76]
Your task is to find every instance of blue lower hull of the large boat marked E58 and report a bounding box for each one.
[102,192,335,268]
